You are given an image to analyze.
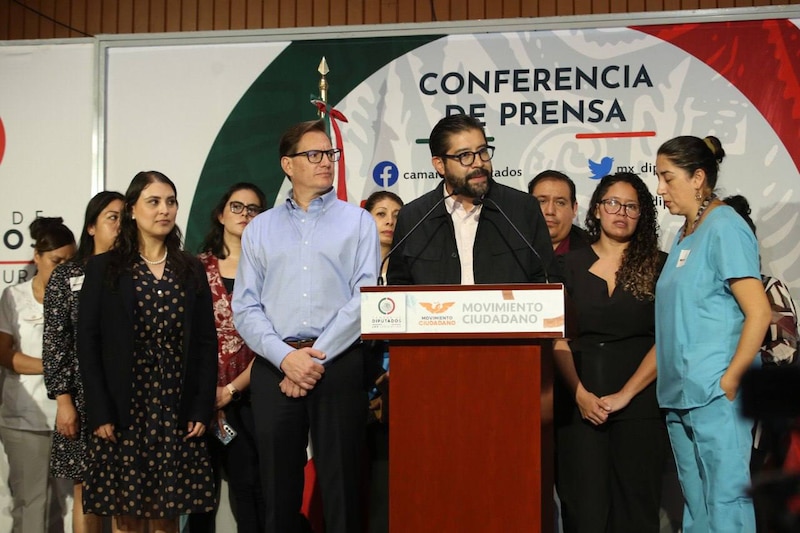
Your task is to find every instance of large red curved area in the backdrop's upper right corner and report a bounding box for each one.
[633,19,800,170]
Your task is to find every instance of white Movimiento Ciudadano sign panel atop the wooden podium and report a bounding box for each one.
[361,284,564,339]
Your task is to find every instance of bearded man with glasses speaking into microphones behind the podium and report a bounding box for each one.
[386,115,560,285]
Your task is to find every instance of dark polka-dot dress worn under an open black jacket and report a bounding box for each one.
[84,261,215,519]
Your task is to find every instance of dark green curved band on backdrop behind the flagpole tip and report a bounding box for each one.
[186,35,441,253]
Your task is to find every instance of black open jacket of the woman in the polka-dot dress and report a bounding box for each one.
[77,253,217,431]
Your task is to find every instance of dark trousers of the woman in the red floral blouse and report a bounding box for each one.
[189,391,266,533]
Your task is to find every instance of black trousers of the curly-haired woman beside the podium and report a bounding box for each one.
[556,414,669,533]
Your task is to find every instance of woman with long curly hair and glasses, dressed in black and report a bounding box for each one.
[554,172,667,533]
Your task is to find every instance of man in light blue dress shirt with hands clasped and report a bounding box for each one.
[233,121,380,533]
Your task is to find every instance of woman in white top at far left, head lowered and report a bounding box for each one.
[0,217,75,533]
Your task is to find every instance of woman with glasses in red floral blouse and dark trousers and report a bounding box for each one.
[189,183,267,533]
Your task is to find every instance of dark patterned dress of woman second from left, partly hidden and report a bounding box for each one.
[42,261,91,481]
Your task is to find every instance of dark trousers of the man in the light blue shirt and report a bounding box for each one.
[250,345,367,533]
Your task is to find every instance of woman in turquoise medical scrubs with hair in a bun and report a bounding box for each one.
[656,136,771,533]
